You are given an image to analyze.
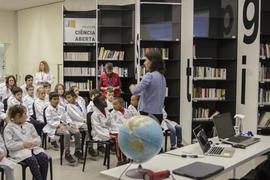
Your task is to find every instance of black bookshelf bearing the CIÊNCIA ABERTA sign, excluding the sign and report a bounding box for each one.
[63,10,96,100]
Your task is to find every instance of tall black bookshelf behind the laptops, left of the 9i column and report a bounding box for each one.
[192,0,237,137]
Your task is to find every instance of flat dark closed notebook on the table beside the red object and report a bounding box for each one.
[173,162,224,179]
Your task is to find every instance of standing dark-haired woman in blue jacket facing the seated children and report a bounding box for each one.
[130,50,166,122]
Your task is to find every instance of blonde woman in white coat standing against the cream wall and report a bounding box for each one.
[35,61,54,88]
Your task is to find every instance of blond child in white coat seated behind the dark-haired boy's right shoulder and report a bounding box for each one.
[33,87,47,136]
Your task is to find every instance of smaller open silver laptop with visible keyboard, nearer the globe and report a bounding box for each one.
[193,126,235,157]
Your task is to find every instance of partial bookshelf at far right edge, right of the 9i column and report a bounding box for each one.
[257,0,270,133]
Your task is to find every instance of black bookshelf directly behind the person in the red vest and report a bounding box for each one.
[97,4,135,103]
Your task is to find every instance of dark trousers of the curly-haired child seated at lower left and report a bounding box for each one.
[23,152,48,180]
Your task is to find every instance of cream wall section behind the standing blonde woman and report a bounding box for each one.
[18,3,63,87]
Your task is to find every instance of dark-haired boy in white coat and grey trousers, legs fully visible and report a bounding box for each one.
[43,92,83,165]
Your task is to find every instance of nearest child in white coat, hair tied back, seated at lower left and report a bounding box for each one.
[4,105,48,180]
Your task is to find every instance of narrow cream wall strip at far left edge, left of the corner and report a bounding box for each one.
[0,10,18,79]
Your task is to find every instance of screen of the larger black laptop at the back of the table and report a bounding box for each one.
[213,112,235,139]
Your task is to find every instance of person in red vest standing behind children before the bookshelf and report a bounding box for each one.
[99,63,122,97]
